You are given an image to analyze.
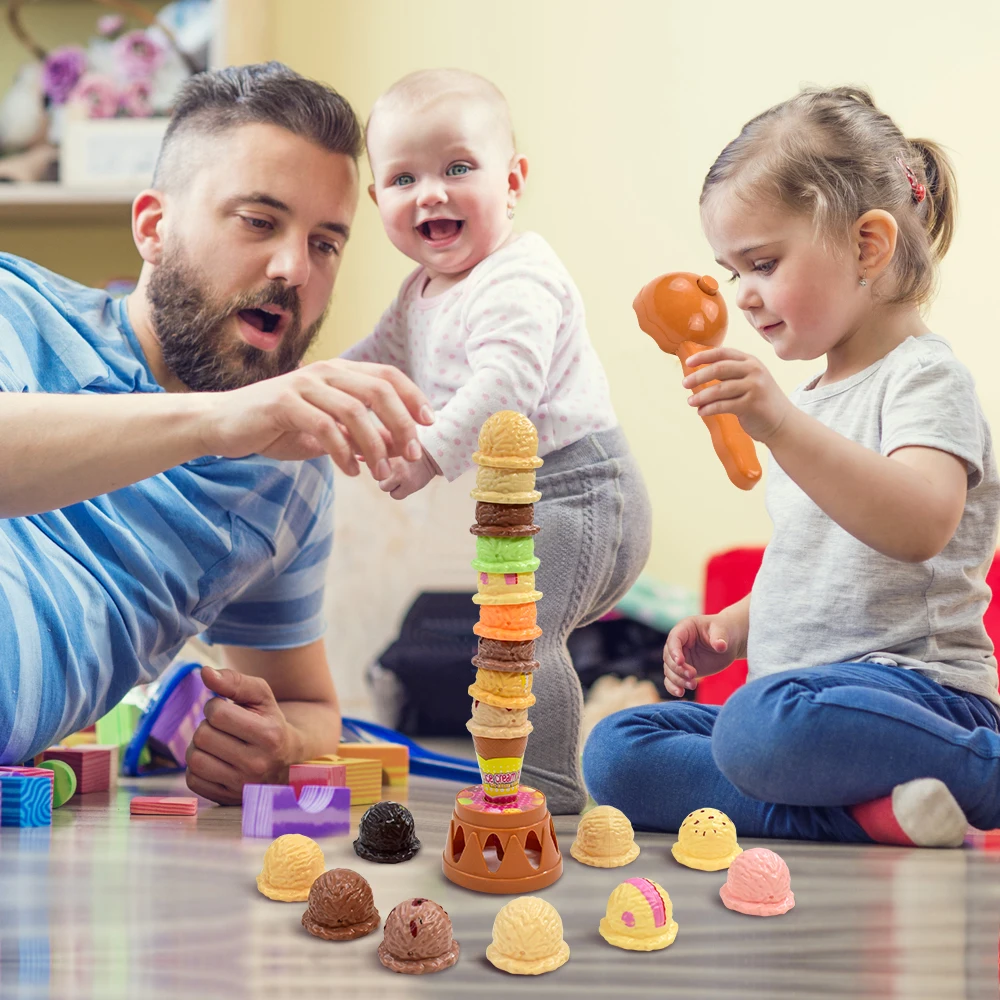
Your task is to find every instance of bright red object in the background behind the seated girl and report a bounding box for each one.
[695,548,1000,705]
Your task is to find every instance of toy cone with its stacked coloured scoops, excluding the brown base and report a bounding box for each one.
[468,410,542,801]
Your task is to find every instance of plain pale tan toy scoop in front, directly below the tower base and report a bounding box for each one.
[486,896,569,976]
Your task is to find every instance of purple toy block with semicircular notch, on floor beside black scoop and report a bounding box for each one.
[243,785,351,839]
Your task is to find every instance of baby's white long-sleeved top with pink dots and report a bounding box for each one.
[343,233,618,481]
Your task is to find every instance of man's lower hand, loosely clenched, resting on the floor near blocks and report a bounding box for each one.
[187,667,301,805]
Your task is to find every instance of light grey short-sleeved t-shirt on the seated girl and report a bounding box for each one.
[747,334,1000,704]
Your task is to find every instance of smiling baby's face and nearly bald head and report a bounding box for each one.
[368,96,523,277]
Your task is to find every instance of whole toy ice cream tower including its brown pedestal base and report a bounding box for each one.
[444,410,562,892]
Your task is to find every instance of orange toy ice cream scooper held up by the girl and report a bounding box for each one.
[632,271,760,490]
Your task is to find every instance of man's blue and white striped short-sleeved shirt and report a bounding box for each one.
[0,253,333,763]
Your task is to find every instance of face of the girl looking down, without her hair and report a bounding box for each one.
[701,186,871,361]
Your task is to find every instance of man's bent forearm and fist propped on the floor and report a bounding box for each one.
[187,639,340,805]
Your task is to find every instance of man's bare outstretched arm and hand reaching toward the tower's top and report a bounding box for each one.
[0,359,434,518]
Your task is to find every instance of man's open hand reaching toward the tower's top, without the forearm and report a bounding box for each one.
[200,358,434,479]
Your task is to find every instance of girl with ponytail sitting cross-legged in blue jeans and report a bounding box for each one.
[584,89,1000,847]
